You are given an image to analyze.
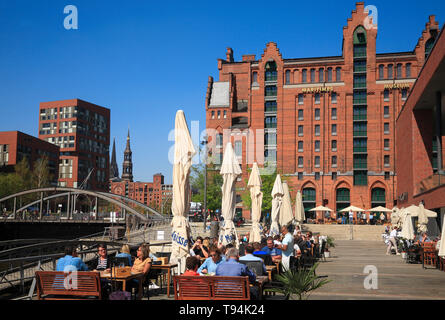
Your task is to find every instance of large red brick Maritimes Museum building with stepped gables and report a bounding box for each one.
[206,2,438,218]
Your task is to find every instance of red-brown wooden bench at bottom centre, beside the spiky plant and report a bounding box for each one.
[173,276,250,300]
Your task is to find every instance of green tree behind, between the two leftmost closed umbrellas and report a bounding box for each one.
[190,164,223,210]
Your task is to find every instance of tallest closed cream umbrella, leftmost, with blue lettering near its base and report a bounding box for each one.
[170,110,196,272]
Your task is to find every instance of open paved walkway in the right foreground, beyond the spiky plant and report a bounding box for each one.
[310,241,445,300]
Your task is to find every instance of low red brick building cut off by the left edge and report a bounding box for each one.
[0,131,59,185]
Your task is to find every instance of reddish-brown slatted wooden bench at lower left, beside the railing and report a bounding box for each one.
[36,271,102,300]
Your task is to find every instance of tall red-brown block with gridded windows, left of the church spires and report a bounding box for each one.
[39,99,110,191]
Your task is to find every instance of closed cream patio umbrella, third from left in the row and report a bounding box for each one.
[247,162,263,242]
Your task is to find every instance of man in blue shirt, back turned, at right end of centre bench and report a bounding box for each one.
[216,248,259,300]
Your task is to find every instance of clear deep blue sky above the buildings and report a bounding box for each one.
[0,0,445,183]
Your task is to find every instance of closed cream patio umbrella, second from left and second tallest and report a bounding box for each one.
[219,142,242,247]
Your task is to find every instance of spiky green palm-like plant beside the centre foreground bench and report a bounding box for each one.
[270,263,332,300]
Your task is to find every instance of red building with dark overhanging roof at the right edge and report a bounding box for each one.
[396,25,445,221]
